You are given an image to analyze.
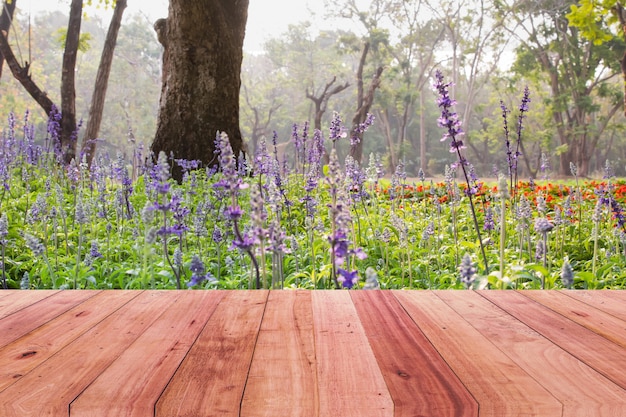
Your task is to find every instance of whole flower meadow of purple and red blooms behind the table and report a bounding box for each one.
[0,77,626,289]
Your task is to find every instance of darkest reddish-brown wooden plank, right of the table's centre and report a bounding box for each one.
[350,291,478,417]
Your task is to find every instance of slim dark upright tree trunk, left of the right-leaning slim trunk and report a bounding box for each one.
[61,0,83,164]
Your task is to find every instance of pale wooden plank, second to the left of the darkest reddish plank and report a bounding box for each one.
[241,291,319,417]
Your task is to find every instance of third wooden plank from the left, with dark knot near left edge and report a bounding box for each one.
[0,291,136,391]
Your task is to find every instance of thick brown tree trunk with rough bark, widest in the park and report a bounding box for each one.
[152,0,248,180]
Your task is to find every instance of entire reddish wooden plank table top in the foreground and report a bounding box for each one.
[0,291,626,417]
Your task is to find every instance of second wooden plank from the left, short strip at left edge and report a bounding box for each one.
[0,291,98,347]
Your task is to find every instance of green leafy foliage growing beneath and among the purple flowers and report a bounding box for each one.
[0,112,626,289]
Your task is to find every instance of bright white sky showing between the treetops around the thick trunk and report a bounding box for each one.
[17,0,323,52]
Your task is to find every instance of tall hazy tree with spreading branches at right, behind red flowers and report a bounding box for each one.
[500,0,623,176]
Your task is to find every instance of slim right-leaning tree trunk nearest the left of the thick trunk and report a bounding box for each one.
[81,0,126,165]
